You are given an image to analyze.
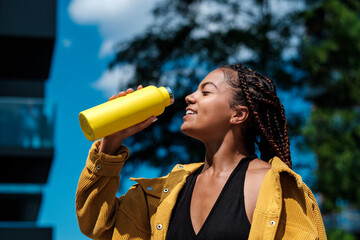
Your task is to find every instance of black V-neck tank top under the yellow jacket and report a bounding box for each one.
[166,156,255,240]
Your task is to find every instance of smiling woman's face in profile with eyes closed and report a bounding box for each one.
[181,69,235,142]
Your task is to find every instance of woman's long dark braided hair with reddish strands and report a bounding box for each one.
[219,64,292,168]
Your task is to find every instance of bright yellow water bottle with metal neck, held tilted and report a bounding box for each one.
[79,86,174,141]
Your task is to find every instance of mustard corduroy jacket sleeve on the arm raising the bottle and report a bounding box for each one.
[76,141,150,239]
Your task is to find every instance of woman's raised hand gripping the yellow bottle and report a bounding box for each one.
[99,85,157,155]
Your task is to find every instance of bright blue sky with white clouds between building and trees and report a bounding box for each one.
[38,0,308,240]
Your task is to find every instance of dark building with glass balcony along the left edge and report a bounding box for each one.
[0,0,56,240]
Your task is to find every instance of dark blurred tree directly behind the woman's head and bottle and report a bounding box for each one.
[110,0,294,176]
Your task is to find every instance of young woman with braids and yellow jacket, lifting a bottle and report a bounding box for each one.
[76,64,326,240]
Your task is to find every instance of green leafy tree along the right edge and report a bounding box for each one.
[301,0,360,212]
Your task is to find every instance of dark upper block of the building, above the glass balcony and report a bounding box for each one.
[0,0,56,97]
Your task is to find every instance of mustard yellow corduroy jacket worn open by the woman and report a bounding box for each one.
[76,142,326,240]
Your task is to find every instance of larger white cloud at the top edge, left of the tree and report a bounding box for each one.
[68,0,158,58]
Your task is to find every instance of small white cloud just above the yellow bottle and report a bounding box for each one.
[91,65,135,98]
